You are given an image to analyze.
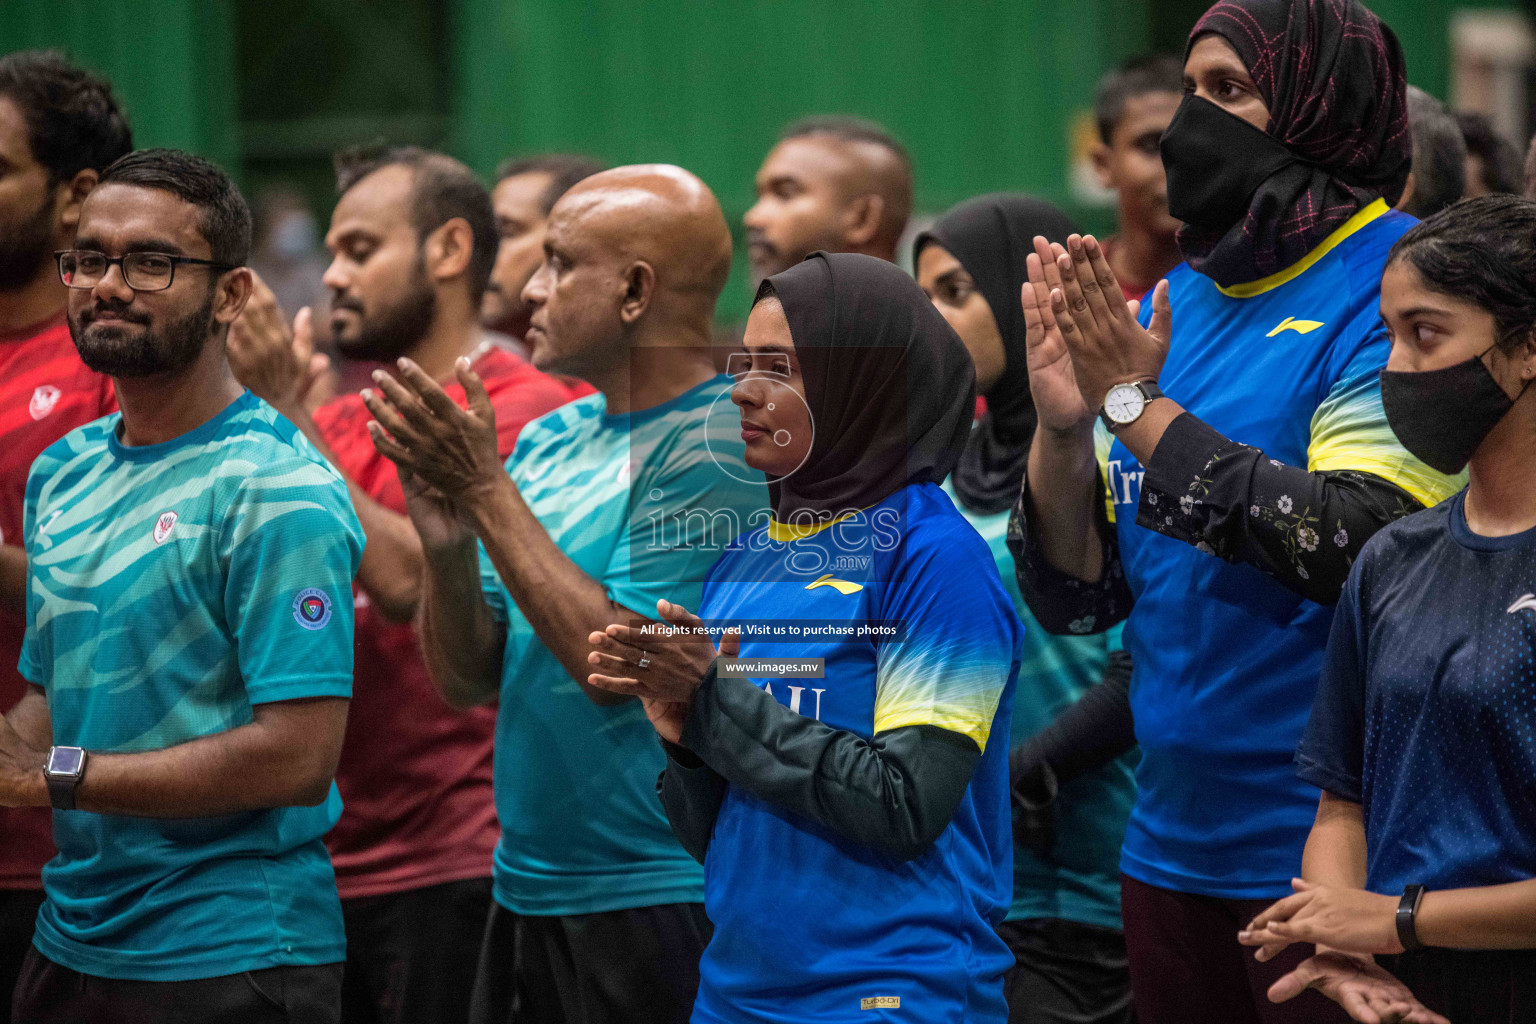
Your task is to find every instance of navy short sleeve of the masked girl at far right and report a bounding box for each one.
[1296,559,1367,803]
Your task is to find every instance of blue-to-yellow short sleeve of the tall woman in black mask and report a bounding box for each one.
[1307,306,1467,508]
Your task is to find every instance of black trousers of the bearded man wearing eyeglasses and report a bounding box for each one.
[11,949,341,1024]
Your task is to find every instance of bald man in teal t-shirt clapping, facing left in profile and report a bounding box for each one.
[364,164,768,1024]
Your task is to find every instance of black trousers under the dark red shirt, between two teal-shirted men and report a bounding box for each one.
[341,878,492,1024]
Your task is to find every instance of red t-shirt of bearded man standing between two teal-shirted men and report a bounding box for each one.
[315,348,591,900]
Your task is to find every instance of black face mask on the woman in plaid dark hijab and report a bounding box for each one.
[1158,94,1303,232]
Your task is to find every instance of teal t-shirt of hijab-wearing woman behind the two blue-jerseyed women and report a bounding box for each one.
[945,481,1137,930]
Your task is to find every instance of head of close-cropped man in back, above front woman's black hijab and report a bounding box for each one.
[742,117,912,287]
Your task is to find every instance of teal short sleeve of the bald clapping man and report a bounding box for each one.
[598,451,768,617]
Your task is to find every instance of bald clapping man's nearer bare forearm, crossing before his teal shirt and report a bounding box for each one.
[470,476,634,705]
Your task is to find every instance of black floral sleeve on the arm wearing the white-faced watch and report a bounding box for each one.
[1137,413,1424,605]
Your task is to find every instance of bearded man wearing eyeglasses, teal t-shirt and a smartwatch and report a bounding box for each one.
[0,149,362,1024]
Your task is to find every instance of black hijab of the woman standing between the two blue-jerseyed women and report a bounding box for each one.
[914,192,1077,516]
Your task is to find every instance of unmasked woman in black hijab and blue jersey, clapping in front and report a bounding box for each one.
[590,253,1021,1024]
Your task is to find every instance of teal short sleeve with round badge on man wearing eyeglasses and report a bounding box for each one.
[221,461,362,705]
